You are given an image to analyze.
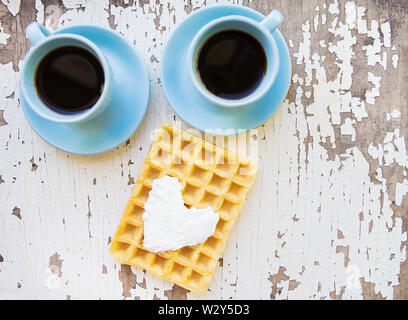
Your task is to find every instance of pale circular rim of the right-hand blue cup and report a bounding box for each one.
[187,15,279,108]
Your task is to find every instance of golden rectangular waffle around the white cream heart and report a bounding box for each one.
[109,124,257,292]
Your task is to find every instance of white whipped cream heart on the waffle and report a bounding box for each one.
[143,176,218,252]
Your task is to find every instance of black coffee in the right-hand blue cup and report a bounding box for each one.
[197,30,266,99]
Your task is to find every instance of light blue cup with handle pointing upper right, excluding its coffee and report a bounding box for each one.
[187,10,283,108]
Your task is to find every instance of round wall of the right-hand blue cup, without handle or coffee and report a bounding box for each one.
[188,16,279,107]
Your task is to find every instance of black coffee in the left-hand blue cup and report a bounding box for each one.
[35,46,104,114]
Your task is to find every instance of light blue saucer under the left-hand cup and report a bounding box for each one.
[21,25,150,155]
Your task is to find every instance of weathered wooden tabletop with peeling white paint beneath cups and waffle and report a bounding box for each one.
[0,0,408,299]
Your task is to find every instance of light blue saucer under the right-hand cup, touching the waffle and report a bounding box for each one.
[161,5,292,135]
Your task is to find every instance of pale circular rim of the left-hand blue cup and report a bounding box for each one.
[21,33,111,124]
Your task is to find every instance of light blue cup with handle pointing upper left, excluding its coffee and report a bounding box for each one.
[21,22,112,124]
